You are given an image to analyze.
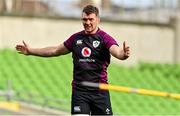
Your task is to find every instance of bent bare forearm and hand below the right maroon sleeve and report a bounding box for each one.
[109,42,130,60]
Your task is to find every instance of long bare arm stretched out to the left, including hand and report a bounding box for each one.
[16,41,70,57]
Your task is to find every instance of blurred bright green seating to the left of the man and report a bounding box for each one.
[0,49,72,109]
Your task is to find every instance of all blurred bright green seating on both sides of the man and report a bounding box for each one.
[0,49,180,115]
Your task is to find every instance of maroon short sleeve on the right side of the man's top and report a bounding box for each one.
[104,34,119,49]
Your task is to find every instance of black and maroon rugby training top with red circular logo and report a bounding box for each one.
[64,29,118,91]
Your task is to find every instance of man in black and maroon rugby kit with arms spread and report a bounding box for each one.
[16,5,130,115]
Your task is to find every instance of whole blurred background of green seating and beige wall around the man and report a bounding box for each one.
[0,0,180,115]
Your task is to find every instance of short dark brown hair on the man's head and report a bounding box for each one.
[82,5,99,16]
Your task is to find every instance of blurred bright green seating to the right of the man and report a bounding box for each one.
[109,63,180,115]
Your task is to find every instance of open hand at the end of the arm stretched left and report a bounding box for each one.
[16,41,30,55]
